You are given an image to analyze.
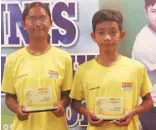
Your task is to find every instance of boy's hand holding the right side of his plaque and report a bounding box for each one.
[111,110,135,126]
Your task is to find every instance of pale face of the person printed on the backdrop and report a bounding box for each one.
[146,3,156,31]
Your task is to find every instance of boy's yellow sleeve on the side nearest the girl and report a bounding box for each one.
[70,67,84,100]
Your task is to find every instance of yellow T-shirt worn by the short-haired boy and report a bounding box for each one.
[70,56,152,130]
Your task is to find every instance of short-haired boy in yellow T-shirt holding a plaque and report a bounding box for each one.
[70,10,153,130]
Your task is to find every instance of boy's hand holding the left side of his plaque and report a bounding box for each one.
[88,113,104,126]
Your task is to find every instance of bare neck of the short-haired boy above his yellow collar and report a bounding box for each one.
[96,51,120,67]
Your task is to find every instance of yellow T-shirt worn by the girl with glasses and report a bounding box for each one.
[2,47,72,130]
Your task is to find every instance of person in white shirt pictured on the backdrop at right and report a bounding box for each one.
[132,0,156,130]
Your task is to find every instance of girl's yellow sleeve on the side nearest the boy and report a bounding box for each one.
[61,55,73,91]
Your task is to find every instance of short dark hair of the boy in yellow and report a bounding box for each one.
[92,9,123,33]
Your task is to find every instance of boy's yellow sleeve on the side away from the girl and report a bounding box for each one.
[140,67,152,97]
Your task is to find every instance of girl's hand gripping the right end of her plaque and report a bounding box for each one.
[52,101,64,117]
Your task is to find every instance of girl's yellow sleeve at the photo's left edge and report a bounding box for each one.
[2,58,16,94]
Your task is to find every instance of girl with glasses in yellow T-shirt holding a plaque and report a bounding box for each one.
[2,2,72,130]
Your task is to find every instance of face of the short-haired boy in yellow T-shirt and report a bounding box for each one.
[91,21,125,52]
